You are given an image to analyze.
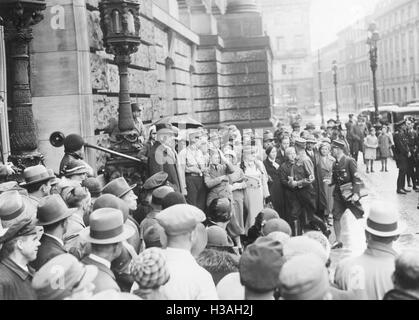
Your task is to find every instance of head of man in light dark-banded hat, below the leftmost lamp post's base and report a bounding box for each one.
[20,165,55,206]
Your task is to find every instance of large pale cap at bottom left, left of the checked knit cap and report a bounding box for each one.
[32,253,98,300]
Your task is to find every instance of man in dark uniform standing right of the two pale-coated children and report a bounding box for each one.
[393,120,412,194]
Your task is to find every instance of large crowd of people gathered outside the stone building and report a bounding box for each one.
[0,114,419,300]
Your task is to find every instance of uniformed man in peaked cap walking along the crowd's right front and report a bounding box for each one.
[330,140,364,249]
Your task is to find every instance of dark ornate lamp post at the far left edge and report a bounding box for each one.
[0,0,46,169]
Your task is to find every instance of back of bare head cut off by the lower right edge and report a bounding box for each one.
[394,250,419,290]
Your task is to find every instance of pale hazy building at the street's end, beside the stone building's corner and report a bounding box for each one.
[258,0,314,115]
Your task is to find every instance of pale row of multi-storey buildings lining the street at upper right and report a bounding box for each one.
[313,0,419,112]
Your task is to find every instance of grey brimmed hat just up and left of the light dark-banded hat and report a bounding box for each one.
[36,194,77,226]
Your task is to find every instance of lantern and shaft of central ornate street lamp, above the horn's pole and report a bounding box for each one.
[99,0,140,151]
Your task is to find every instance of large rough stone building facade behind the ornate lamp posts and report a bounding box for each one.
[0,0,273,171]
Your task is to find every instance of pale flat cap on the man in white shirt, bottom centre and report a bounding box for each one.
[156,204,206,236]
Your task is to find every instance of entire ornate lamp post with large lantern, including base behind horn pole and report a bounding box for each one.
[99,0,143,186]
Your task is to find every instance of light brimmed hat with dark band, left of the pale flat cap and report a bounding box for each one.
[80,208,135,244]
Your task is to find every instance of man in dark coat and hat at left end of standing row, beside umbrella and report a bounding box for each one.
[148,123,186,194]
